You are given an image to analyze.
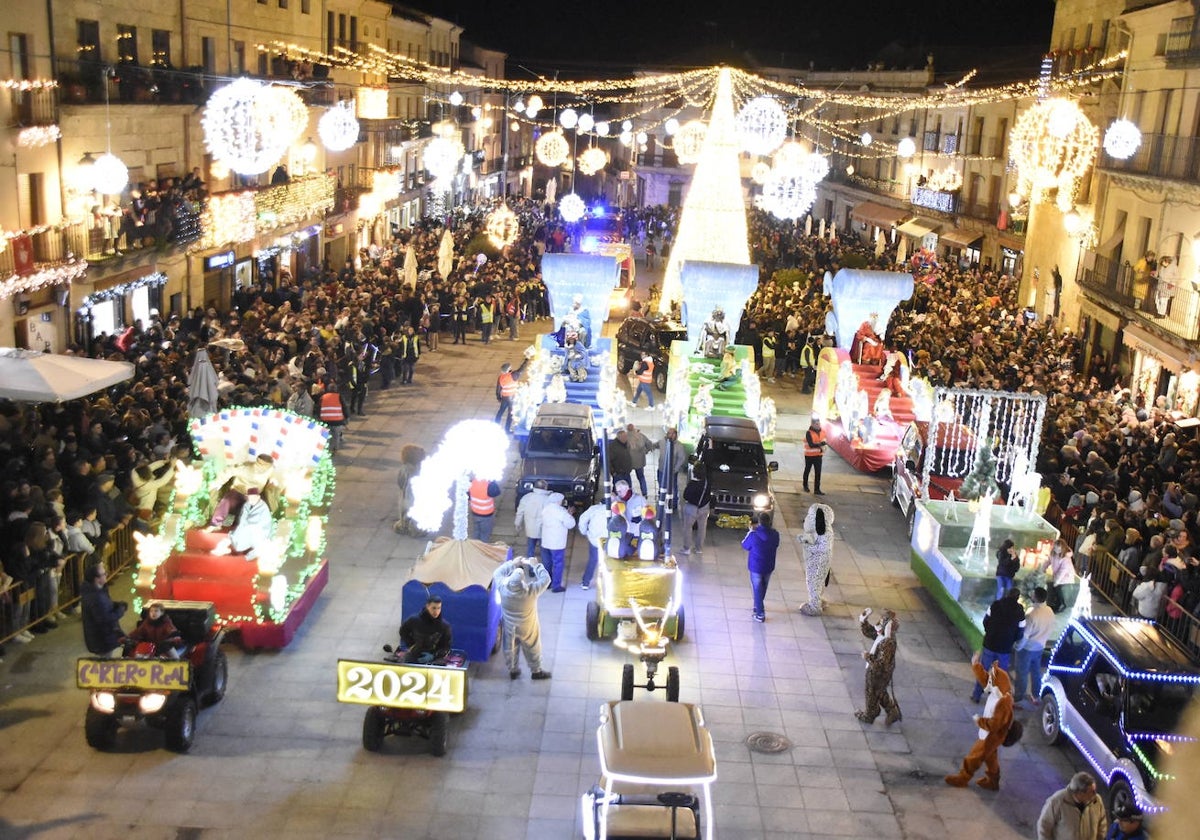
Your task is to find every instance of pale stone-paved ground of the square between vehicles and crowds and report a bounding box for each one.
[0,312,1082,840]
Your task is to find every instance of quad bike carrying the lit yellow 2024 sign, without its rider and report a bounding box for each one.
[337,644,467,756]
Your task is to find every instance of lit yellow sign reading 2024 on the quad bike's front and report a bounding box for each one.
[337,659,467,712]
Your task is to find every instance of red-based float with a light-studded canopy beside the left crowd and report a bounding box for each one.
[132,407,335,649]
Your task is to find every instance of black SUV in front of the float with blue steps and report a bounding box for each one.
[517,402,600,510]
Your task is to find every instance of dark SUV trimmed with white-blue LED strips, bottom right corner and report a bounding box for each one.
[1042,617,1200,814]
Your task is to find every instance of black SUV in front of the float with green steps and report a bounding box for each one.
[692,416,779,516]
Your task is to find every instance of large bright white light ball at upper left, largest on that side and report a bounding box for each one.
[200,78,295,175]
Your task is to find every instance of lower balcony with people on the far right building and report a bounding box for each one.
[1076,251,1200,341]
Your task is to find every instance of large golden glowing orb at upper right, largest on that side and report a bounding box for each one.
[1009,97,1100,200]
